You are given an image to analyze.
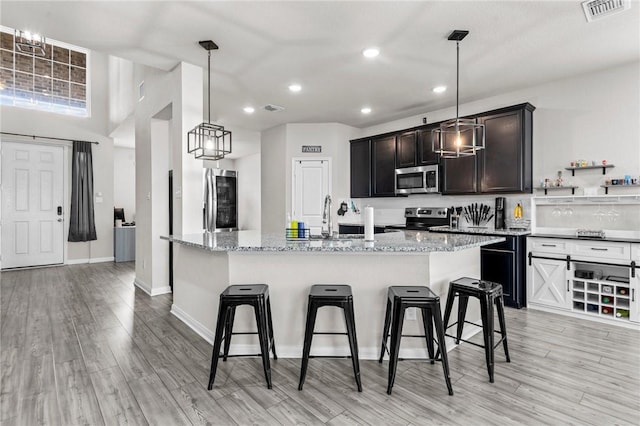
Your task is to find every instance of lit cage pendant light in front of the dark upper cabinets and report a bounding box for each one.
[431,30,485,158]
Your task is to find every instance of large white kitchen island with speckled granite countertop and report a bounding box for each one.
[162,231,504,359]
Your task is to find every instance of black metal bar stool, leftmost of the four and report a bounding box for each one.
[209,284,278,390]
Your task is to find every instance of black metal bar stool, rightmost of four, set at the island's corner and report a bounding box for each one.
[444,277,511,383]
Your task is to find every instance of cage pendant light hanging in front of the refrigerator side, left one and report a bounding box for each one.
[187,40,231,160]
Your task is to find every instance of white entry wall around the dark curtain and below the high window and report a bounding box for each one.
[0,52,113,263]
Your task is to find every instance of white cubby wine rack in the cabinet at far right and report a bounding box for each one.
[571,276,631,321]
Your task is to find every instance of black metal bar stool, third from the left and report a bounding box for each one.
[378,286,453,395]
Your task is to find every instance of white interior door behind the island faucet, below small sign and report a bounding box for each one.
[291,159,331,235]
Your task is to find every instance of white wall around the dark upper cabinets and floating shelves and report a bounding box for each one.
[344,62,640,223]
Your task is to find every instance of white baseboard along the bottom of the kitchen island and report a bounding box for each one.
[171,304,481,360]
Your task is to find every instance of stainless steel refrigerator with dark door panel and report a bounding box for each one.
[203,169,238,232]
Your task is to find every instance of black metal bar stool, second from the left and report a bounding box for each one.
[298,284,362,392]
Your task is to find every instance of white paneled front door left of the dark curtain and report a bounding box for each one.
[2,142,64,269]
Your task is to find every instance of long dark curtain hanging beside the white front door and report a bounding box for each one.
[69,141,98,242]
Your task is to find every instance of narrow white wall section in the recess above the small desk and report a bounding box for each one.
[113,146,136,222]
